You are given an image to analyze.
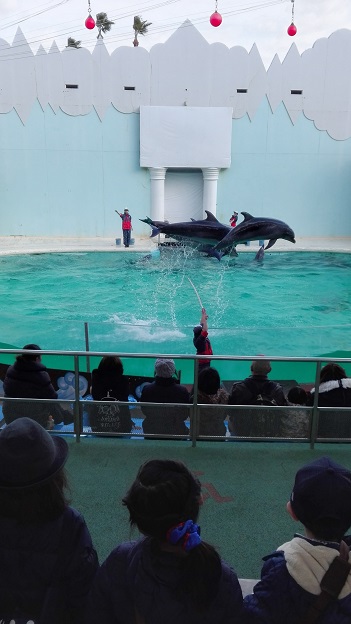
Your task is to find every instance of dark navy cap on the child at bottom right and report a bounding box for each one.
[290,457,351,539]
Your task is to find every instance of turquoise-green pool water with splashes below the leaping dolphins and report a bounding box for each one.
[0,249,351,378]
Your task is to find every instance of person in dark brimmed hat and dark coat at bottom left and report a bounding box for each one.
[0,418,98,624]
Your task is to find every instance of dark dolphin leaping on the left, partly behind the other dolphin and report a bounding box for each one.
[140,210,232,251]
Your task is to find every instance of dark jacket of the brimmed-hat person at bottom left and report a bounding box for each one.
[0,507,98,624]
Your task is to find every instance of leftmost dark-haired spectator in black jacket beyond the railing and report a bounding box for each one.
[2,344,73,429]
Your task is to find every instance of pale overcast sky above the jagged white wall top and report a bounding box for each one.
[0,0,351,68]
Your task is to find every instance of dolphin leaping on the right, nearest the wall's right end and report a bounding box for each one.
[209,212,296,260]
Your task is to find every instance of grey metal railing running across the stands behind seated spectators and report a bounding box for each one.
[0,349,351,448]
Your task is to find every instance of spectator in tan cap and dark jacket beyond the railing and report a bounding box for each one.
[228,360,286,437]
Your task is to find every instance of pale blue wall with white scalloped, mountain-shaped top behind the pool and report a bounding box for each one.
[0,21,351,236]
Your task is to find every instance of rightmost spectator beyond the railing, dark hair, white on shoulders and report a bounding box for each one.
[307,362,351,438]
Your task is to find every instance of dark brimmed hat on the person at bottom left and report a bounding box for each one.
[0,418,68,489]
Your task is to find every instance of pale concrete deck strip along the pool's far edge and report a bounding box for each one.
[0,236,351,256]
